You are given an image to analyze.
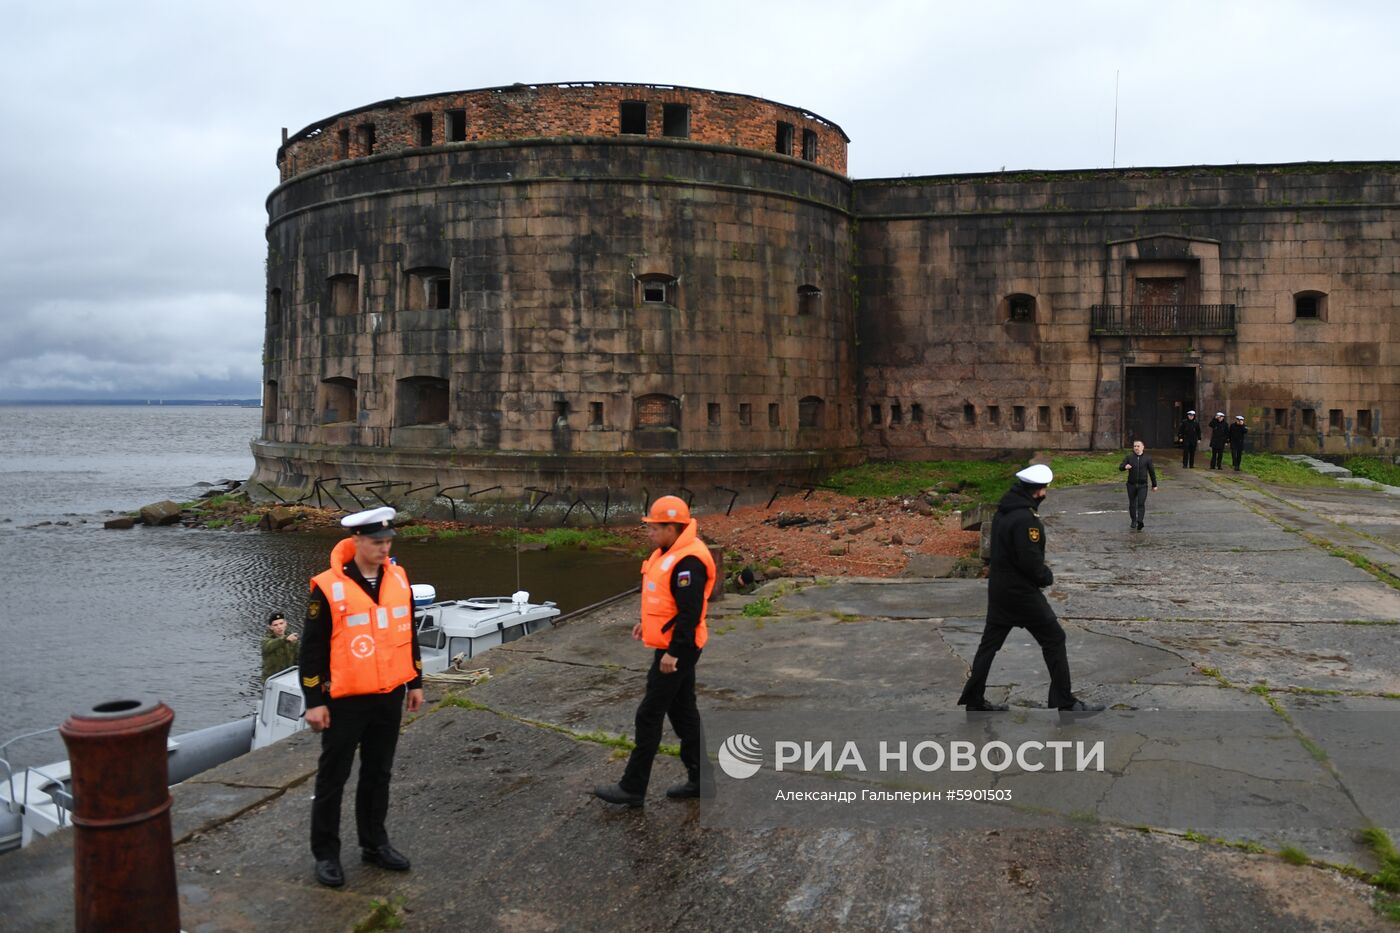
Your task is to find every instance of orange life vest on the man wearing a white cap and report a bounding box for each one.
[311,538,419,698]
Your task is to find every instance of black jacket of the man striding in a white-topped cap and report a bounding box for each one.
[987,483,1054,625]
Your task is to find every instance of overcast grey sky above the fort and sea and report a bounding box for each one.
[0,0,1400,399]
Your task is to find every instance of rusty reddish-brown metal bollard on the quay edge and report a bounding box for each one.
[59,699,179,933]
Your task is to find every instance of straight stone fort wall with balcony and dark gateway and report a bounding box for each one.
[854,164,1400,457]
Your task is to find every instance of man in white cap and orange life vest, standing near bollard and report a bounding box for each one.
[300,509,423,887]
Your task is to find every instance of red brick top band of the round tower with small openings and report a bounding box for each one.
[277,84,847,181]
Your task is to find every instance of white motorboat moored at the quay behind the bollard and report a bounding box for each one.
[0,583,559,853]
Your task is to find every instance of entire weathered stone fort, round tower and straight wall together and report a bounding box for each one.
[253,83,1400,511]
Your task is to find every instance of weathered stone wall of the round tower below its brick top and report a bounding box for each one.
[256,139,858,492]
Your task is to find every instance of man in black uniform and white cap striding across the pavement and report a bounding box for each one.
[958,464,1103,713]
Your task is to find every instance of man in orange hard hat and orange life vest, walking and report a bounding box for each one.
[594,496,715,807]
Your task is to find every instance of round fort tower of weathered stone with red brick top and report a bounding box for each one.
[253,84,860,510]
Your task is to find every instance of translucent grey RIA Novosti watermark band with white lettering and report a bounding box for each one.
[701,706,1400,838]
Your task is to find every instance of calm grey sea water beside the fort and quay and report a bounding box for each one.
[0,406,637,763]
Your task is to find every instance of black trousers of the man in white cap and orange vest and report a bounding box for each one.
[311,686,403,860]
